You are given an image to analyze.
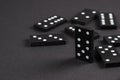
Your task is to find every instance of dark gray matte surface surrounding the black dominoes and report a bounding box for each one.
[0,0,120,80]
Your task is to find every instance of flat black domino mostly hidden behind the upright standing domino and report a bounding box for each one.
[65,25,100,40]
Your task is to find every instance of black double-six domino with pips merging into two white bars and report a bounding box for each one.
[97,13,117,29]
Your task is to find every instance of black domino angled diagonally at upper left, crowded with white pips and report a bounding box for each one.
[34,15,67,31]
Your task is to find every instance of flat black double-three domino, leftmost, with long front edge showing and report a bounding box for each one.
[29,34,66,46]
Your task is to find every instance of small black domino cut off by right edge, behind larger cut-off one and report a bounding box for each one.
[103,34,120,47]
